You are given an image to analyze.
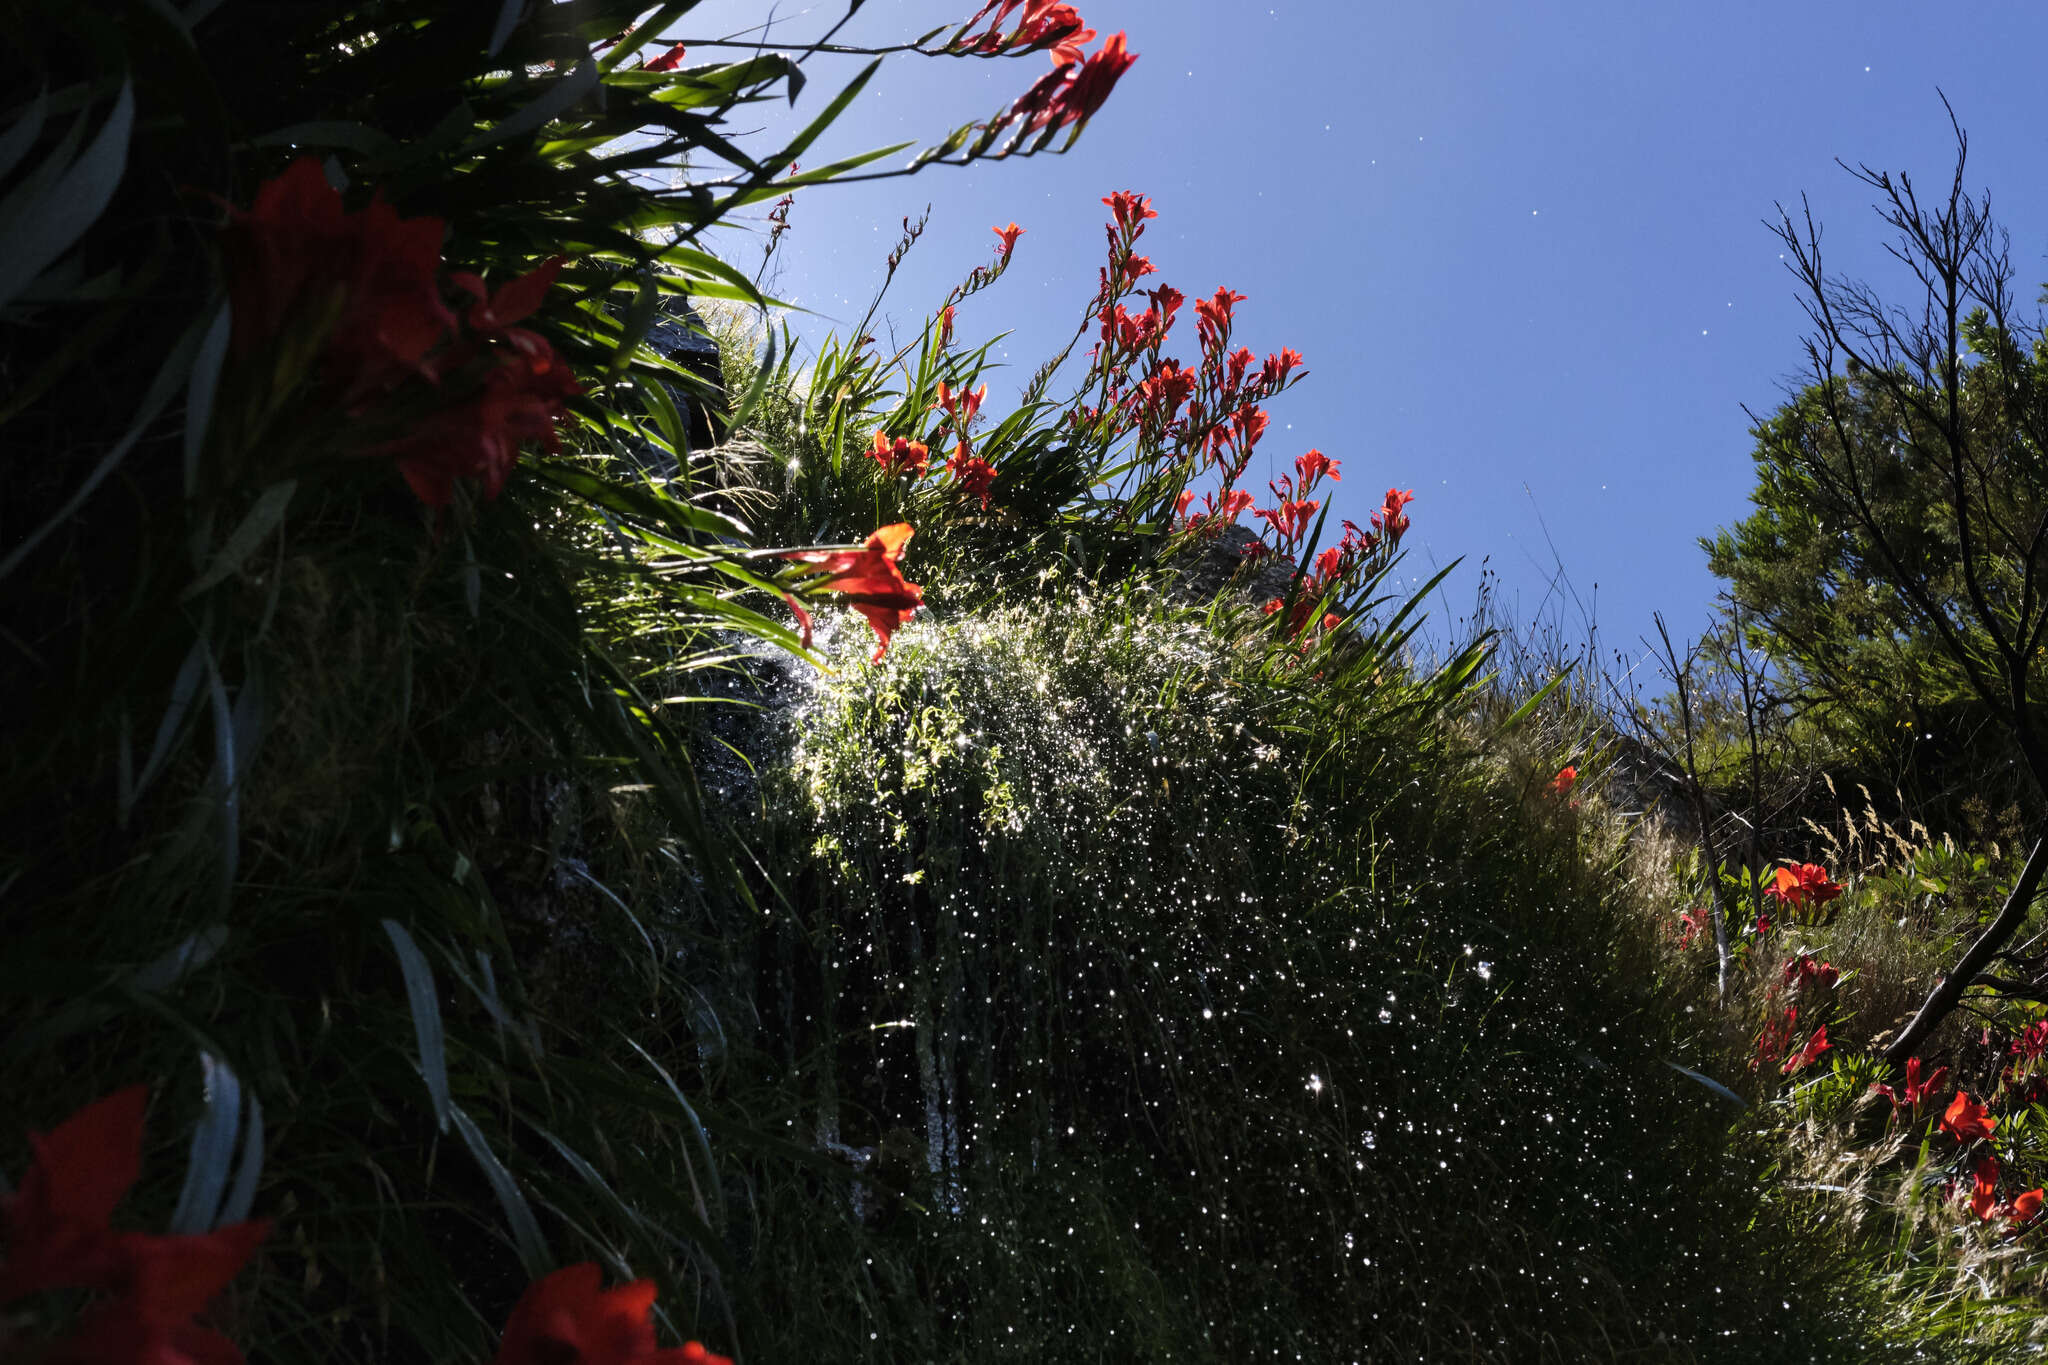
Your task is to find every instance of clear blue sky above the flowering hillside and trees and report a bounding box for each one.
[688,0,2048,651]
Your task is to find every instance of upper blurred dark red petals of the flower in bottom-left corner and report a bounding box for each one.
[0,1085,150,1304]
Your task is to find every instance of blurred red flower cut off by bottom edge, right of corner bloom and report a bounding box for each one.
[494,1261,731,1365]
